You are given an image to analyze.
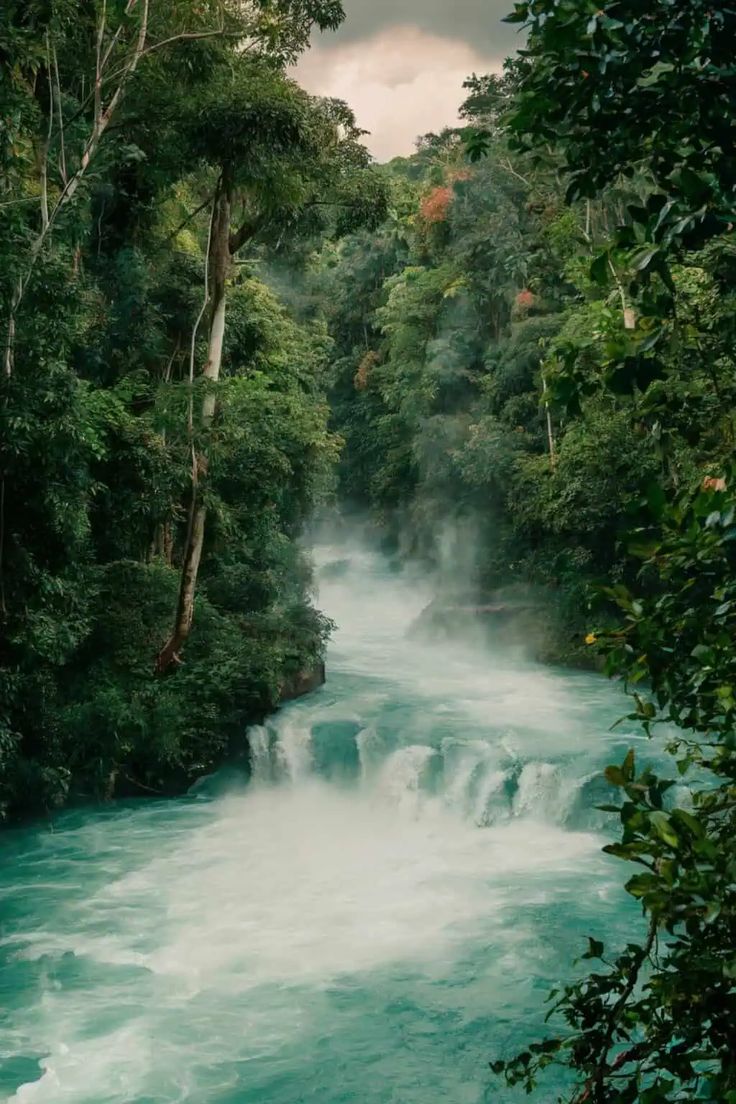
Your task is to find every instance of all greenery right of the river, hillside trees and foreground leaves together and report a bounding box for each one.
[308,12,736,1104]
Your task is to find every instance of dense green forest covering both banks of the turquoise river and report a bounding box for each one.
[0,0,736,1104]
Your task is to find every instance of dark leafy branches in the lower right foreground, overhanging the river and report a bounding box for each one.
[494,473,736,1102]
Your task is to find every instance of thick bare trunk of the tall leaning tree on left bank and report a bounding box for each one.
[156,176,232,673]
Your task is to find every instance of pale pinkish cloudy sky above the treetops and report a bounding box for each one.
[298,0,519,160]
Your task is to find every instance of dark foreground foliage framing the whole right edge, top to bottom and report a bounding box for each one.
[474,0,736,1104]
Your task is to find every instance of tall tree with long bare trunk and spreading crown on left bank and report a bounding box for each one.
[157,69,382,671]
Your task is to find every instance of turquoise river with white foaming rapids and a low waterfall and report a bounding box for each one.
[0,548,639,1104]
